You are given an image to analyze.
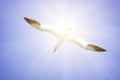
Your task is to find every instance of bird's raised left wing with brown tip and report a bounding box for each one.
[24,17,60,37]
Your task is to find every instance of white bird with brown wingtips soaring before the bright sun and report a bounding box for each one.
[24,17,106,53]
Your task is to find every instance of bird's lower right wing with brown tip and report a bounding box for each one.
[68,36,106,52]
